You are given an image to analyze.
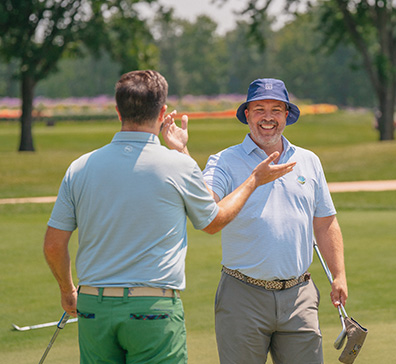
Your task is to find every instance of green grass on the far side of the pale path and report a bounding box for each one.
[0,111,396,198]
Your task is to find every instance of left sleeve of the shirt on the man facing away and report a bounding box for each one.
[48,168,77,231]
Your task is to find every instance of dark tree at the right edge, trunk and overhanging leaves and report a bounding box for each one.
[217,0,396,140]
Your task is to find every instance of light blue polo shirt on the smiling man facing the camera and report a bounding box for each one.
[203,135,336,280]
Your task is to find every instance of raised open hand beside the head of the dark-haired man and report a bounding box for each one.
[161,110,188,154]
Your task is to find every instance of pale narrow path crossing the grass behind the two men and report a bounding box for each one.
[0,180,396,205]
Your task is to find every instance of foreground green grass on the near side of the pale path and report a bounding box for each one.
[0,203,396,364]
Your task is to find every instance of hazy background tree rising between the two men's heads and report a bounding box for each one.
[155,11,227,96]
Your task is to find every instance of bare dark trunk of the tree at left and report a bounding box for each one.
[19,73,35,152]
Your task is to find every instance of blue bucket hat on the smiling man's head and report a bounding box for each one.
[236,78,300,125]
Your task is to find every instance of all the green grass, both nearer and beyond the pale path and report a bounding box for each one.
[0,112,396,364]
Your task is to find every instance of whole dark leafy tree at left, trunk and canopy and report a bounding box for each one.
[0,0,156,151]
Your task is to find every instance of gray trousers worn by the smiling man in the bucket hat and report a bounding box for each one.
[215,273,323,364]
